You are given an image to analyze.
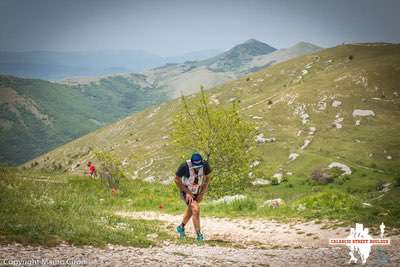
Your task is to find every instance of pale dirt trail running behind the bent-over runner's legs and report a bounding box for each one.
[115,212,349,248]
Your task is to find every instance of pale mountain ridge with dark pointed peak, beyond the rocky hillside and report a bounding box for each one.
[144,39,321,98]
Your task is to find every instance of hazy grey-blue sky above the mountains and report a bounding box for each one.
[0,0,400,56]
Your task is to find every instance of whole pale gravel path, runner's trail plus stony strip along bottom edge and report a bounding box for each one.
[0,212,400,266]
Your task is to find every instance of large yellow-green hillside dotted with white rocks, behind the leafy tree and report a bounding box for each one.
[25,44,400,187]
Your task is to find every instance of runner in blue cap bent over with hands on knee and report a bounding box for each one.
[175,153,211,241]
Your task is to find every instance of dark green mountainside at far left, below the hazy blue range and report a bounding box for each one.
[0,75,167,164]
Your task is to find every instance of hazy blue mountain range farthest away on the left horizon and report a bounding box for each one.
[0,50,219,80]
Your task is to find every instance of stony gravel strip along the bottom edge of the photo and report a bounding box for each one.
[0,243,400,266]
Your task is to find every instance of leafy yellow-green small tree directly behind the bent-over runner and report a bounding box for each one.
[172,87,255,196]
